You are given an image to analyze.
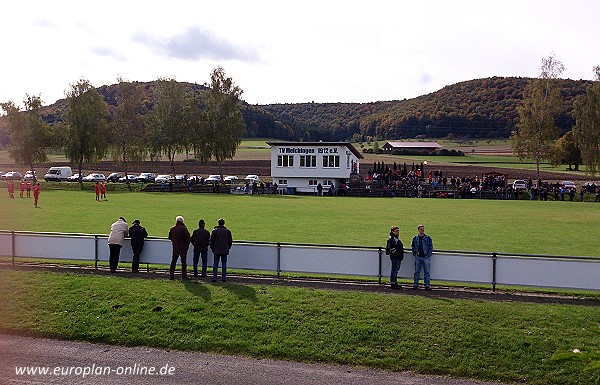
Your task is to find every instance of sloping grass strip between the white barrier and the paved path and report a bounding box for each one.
[0,270,600,384]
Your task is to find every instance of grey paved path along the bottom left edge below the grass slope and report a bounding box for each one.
[0,334,510,385]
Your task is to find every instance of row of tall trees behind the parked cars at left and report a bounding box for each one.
[0,67,246,181]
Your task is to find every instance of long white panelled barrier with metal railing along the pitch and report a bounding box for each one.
[0,231,600,290]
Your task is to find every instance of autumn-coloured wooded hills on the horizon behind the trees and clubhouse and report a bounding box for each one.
[0,77,592,144]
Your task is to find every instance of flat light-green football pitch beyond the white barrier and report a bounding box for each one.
[0,190,600,257]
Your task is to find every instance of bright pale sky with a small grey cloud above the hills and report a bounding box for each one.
[0,0,600,106]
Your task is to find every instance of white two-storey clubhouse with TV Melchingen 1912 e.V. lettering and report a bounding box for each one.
[267,142,363,193]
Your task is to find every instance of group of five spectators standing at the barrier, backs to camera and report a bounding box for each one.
[108,215,233,282]
